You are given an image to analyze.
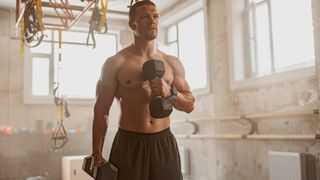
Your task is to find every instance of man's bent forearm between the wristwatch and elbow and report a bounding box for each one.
[172,92,195,113]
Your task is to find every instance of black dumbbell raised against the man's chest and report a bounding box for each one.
[142,59,173,118]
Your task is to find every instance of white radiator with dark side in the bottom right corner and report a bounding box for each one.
[269,151,317,180]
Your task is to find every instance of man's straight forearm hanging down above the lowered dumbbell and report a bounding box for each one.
[92,115,108,158]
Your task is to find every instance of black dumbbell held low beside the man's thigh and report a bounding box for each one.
[82,156,118,180]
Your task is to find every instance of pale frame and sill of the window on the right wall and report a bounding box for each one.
[227,0,316,90]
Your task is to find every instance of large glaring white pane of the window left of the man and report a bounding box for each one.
[55,32,116,99]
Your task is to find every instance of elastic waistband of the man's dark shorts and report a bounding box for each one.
[118,128,171,140]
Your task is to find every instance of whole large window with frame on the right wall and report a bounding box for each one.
[229,0,315,87]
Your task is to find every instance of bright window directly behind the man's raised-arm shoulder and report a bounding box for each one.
[160,10,208,91]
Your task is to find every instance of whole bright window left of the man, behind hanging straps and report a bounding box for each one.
[25,31,117,103]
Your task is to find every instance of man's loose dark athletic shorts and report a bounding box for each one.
[109,128,182,180]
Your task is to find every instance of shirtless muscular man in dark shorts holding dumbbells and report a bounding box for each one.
[92,1,195,180]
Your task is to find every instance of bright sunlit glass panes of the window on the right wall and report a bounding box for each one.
[248,0,315,77]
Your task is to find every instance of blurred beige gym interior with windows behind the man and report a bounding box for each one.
[0,0,320,180]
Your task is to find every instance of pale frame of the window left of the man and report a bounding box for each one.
[23,29,120,105]
